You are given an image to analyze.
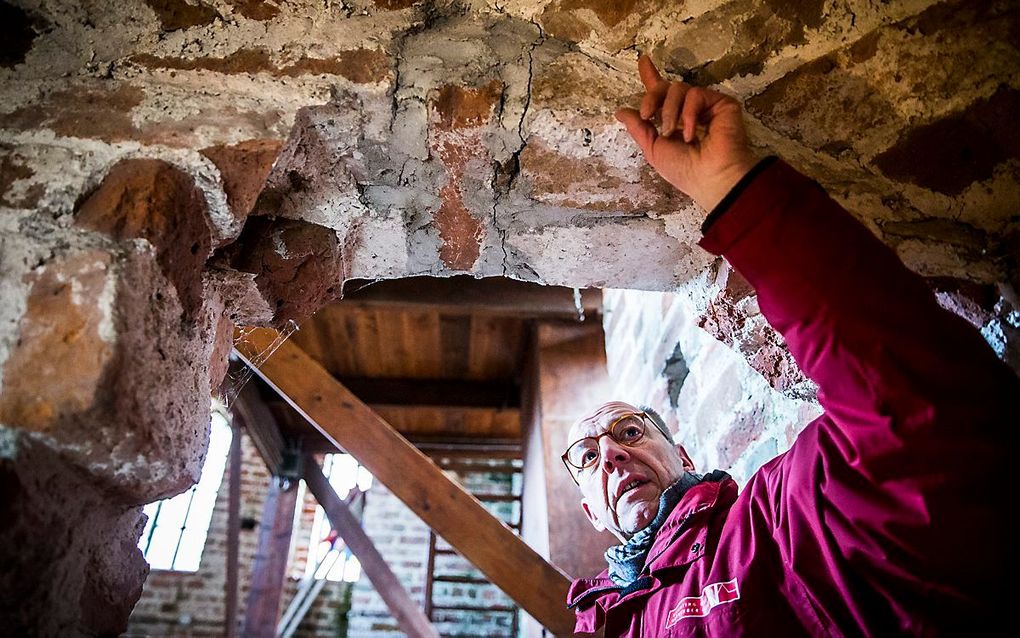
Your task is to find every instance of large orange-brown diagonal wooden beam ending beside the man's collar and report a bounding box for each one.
[235,329,573,636]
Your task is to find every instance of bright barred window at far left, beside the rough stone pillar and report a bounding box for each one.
[138,404,232,572]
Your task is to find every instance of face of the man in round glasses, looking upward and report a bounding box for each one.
[567,401,694,541]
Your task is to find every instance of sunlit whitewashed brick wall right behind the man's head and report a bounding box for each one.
[603,290,820,485]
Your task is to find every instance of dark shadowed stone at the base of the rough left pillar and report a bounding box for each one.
[0,432,148,636]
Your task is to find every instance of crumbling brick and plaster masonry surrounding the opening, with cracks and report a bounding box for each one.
[0,0,1020,635]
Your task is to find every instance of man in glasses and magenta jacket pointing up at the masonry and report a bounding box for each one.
[563,57,1020,637]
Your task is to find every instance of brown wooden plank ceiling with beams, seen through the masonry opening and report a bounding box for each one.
[273,277,601,449]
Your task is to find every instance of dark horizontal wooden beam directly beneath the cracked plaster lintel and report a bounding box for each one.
[339,275,602,321]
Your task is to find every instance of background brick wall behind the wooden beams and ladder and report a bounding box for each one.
[125,437,520,638]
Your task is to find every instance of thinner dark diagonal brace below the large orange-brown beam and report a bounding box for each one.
[303,456,440,638]
